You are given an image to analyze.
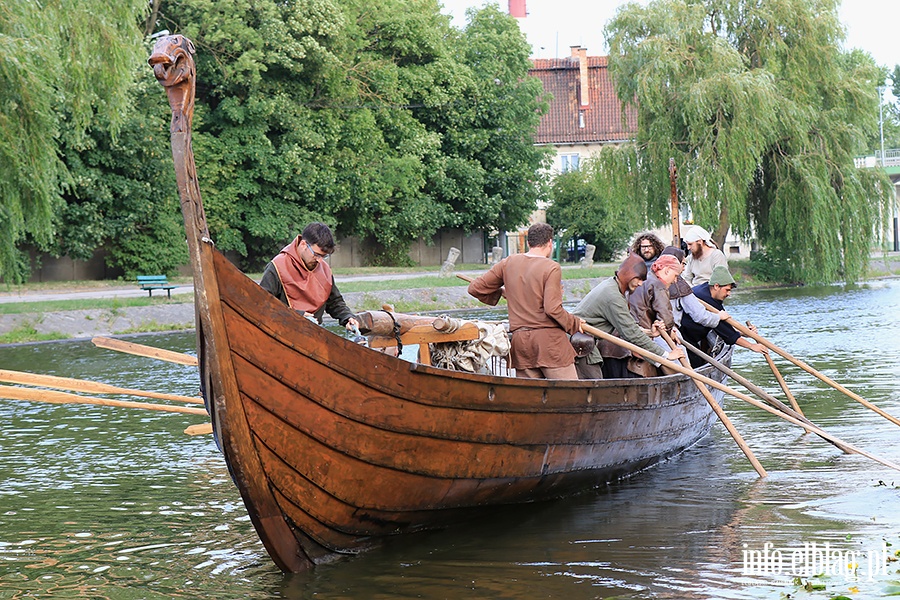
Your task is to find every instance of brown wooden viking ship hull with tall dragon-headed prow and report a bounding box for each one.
[149,35,730,572]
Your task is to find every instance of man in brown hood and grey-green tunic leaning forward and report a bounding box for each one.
[572,252,684,379]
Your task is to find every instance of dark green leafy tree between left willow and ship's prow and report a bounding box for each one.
[54,68,187,278]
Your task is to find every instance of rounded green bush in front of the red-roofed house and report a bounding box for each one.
[547,146,644,260]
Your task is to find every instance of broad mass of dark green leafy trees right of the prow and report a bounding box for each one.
[155,0,546,266]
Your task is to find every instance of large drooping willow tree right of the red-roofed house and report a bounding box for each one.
[606,0,890,281]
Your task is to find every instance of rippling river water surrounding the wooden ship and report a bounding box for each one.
[0,280,900,600]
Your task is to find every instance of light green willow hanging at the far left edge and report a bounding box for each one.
[0,0,147,281]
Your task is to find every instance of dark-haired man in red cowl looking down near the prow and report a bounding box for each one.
[259,222,359,330]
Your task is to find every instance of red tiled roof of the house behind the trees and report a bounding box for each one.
[528,56,637,144]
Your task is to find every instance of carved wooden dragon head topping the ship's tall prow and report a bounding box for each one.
[147,35,196,133]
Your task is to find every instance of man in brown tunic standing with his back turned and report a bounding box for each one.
[469,223,584,379]
